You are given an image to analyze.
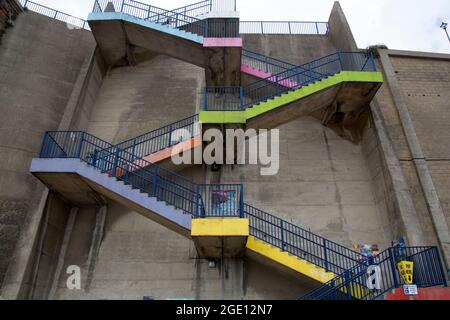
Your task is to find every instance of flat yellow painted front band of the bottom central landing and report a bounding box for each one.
[191,218,249,237]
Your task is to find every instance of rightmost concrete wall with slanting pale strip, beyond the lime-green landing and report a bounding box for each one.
[380,50,450,268]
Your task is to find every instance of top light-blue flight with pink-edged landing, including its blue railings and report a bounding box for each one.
[88,0,242,85]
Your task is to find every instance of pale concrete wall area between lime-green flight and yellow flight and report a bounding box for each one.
[221,117,392,248]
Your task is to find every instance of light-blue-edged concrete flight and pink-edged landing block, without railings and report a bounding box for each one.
[88,12,242,86]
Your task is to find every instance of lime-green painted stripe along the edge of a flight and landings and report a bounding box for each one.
[200,71,383,124]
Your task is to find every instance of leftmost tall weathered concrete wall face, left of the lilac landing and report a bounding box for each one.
[0,12,94,294]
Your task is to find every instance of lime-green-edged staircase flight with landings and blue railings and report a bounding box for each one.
[200,52,383,129]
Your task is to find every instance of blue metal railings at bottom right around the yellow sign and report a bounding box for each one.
[300,247,447,300]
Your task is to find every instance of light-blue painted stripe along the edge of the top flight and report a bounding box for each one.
[87,12,203,45]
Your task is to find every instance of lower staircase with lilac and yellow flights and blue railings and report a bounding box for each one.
[30,131,445,299]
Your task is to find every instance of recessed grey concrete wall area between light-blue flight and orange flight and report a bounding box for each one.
[88,56,205,143]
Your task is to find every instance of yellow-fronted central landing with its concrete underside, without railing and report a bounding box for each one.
[191,218,249,258]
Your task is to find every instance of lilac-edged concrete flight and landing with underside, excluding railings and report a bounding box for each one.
[30,159,191,238]
